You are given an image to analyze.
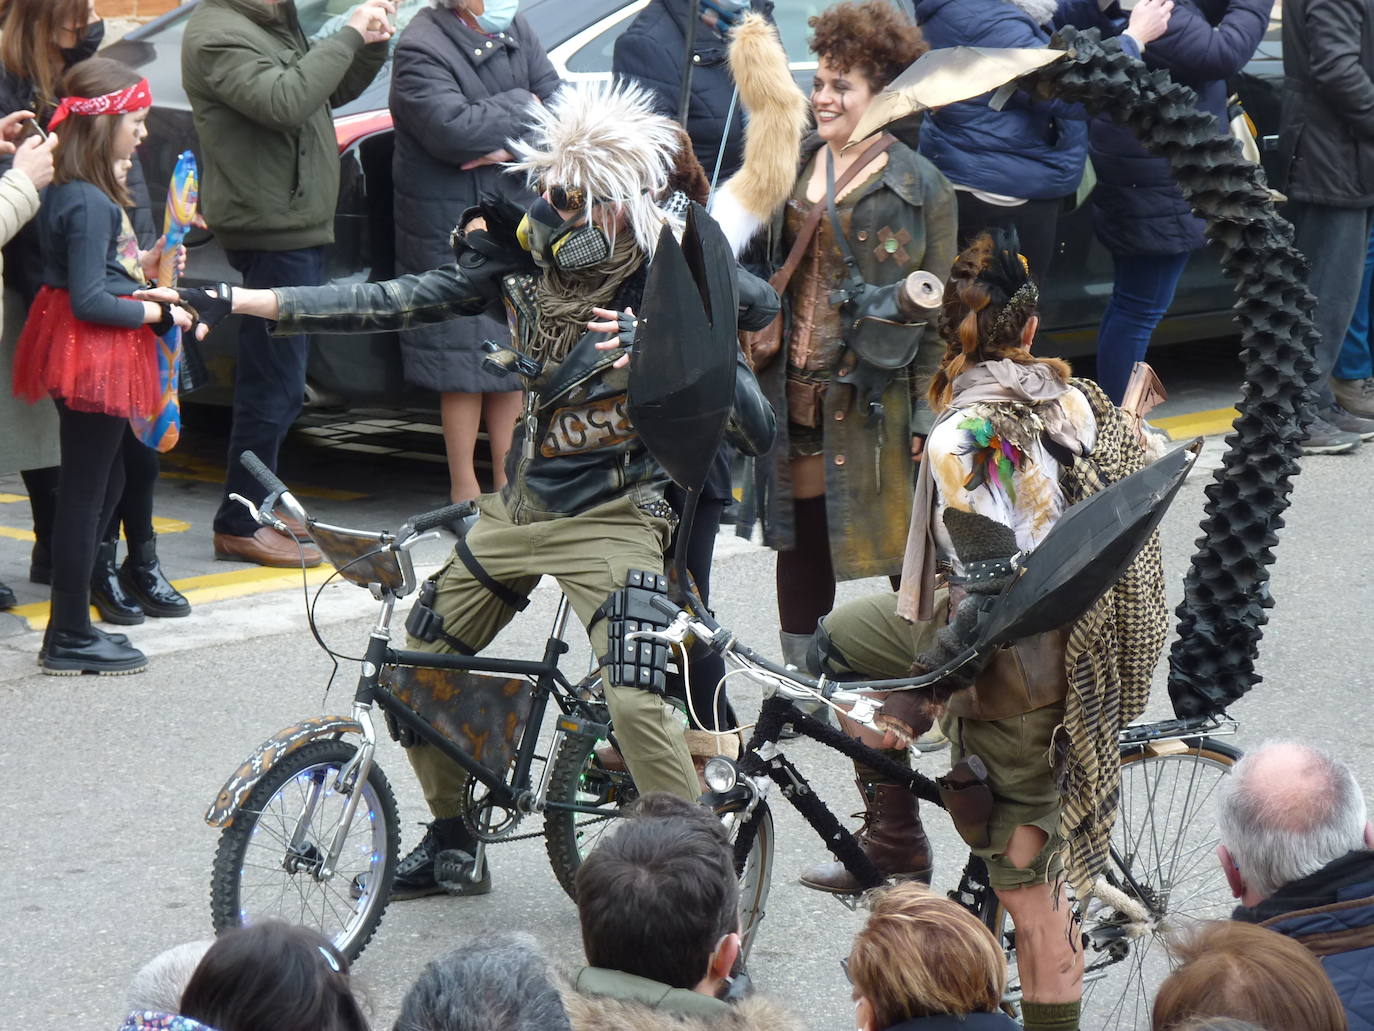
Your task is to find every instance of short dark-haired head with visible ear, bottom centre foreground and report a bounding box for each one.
[577,792,739,995]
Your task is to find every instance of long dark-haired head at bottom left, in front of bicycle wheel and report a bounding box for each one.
[180,921,368,1031]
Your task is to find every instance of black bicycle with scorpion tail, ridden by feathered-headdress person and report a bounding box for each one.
[651,605,1241,1028]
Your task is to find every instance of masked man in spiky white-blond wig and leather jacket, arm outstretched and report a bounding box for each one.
[155,84,778,899]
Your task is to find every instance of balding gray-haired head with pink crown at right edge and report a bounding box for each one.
[1217,741,1367,899]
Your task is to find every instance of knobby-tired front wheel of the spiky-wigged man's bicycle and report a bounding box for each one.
[210,740,400,961]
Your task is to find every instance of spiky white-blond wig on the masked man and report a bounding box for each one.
[508,80,682,254]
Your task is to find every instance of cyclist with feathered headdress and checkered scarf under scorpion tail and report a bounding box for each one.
[802,230,1167,1031]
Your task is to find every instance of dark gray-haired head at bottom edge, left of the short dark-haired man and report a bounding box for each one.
[394,935,572,1031]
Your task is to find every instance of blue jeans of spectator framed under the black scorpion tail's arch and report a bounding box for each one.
[1098,253,1189,404]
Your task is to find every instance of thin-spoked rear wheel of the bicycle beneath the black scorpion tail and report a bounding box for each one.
[982,737,1241,1031]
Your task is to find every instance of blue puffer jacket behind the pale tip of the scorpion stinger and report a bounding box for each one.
[916,0,1115,201]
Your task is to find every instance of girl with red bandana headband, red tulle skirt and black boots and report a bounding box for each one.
[14,58,191,675]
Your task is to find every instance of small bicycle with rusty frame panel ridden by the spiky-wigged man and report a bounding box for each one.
[206,452,772,960]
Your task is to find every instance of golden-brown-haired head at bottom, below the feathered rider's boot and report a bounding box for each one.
[845,883,1017,1031]
